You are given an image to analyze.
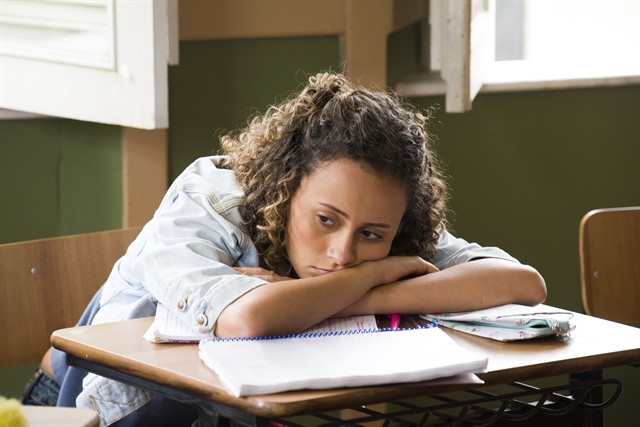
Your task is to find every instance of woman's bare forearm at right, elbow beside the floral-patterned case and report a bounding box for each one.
[335,258,547,317]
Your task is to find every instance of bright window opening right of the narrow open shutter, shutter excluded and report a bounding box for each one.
[485,0,640,90]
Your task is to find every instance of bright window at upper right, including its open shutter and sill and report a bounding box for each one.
[395,0,640,112]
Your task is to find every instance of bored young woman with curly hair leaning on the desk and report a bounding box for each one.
[23,74,546,425]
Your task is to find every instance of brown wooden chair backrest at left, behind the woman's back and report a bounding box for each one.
[0,228,141,369]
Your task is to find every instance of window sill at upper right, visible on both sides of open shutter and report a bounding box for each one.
[394,61,640,98]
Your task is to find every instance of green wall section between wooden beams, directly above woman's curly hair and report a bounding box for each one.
[169,36,340,179]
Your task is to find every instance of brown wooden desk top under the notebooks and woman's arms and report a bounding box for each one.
[51,313,640,418]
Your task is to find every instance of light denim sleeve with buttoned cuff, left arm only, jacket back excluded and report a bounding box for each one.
[136,181,266,332]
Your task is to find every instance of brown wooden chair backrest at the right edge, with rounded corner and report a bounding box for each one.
[580,206,640,324]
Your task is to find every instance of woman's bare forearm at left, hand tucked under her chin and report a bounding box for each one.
[215,257,436,337]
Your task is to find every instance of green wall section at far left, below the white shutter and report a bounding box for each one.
[0,119,122,243]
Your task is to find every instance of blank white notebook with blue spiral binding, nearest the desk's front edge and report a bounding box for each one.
[199,327,487,397]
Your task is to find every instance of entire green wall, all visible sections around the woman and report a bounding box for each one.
[0,32,640,426]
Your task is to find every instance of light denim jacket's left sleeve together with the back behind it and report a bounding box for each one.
[95,164,266,333]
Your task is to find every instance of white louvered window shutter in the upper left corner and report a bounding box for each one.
[0,0,178,129]
